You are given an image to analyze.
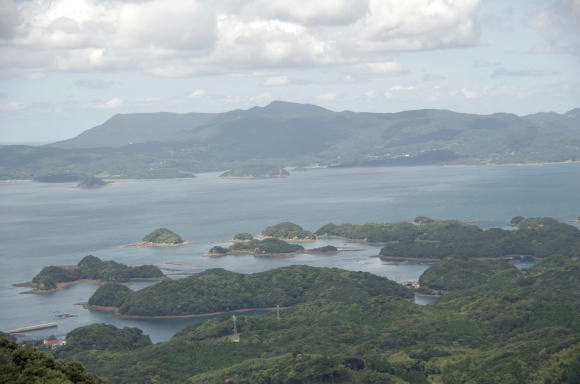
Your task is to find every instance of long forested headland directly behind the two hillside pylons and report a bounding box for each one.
[89,266,413,316]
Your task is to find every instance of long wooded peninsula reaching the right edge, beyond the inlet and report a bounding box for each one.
[316,217,580,259]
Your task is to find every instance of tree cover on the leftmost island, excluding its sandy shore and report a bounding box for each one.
[32,255,164,289]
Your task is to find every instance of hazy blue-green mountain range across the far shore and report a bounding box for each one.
[0,101,580,179]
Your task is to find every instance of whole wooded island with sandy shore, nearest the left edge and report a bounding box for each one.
[14,255,167,294]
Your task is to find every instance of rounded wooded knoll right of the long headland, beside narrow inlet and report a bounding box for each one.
[419,257,516,291]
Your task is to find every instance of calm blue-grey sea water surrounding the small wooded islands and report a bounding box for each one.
[0,164,580,341]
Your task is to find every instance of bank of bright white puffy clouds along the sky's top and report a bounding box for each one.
[0,0,480,77]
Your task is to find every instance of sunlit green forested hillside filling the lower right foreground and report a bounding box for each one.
[53,256,580,384]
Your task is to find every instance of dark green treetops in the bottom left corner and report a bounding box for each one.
[0,337,105,384]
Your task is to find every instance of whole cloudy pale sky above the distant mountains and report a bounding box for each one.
[0,0,580,144]
